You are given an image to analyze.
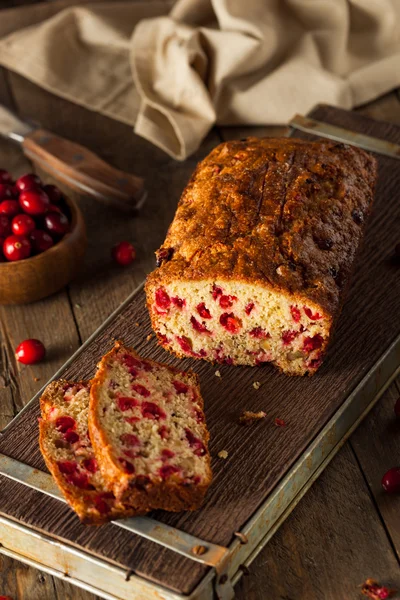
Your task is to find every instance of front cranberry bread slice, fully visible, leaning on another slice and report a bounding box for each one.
[89,343,211,511]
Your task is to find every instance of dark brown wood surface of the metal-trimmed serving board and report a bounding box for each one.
[0,107,400,593]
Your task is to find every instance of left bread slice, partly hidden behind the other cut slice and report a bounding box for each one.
[39,380,138,525]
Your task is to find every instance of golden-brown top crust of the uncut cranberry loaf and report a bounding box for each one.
[148,138,377,316]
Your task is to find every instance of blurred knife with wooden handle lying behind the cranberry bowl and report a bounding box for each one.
[0,105,147,212]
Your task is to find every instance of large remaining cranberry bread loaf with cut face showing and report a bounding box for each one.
[146,138,377,375]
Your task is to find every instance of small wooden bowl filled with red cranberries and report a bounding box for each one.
[0,170,86,304]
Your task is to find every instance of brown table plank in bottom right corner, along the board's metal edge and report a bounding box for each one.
[237,444,400,600]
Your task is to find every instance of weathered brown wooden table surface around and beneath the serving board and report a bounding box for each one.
[0,2,400,600]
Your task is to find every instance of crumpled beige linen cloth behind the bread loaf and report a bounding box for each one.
[0,0,400,160]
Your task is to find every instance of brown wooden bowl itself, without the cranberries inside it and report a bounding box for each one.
[0,198,87,304]
